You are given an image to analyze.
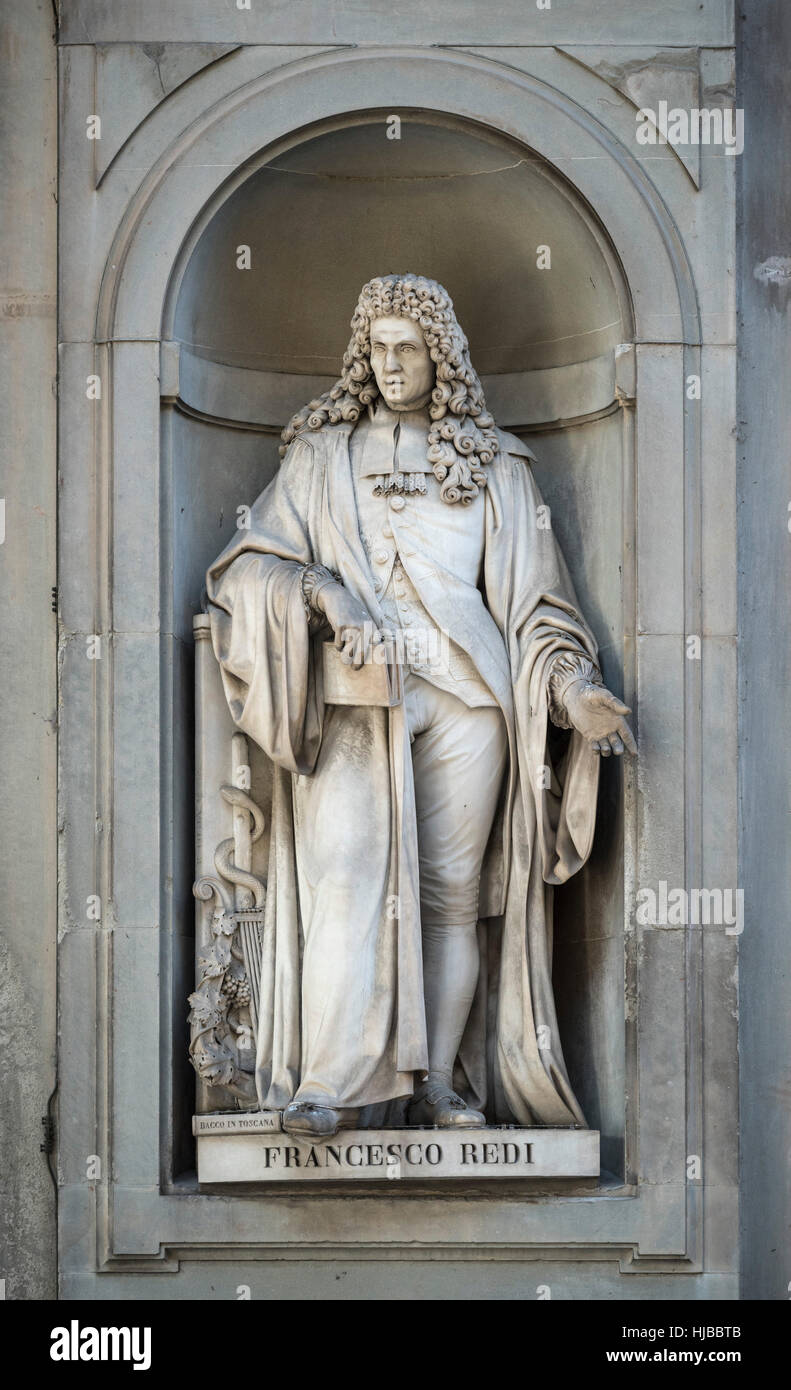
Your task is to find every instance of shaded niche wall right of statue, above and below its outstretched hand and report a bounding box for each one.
[524,414,626,1177]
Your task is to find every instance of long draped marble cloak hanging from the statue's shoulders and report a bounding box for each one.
[207,424,599,1126]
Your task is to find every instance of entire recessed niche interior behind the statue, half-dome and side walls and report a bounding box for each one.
[163,113,628,1180]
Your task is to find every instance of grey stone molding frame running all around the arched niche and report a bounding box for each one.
[55,40,734,1273]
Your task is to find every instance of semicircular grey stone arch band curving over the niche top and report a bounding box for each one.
[96,47,699,343]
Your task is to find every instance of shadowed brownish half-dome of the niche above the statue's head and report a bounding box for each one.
[172,111,631,378]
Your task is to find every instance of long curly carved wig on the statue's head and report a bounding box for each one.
[279,275,498,503]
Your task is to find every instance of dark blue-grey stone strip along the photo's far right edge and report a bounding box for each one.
[730,0,791,1300]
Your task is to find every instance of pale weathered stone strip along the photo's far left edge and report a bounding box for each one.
[0,0,58,1300]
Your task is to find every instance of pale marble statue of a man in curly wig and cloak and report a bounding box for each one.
[207,275,634,1137]
